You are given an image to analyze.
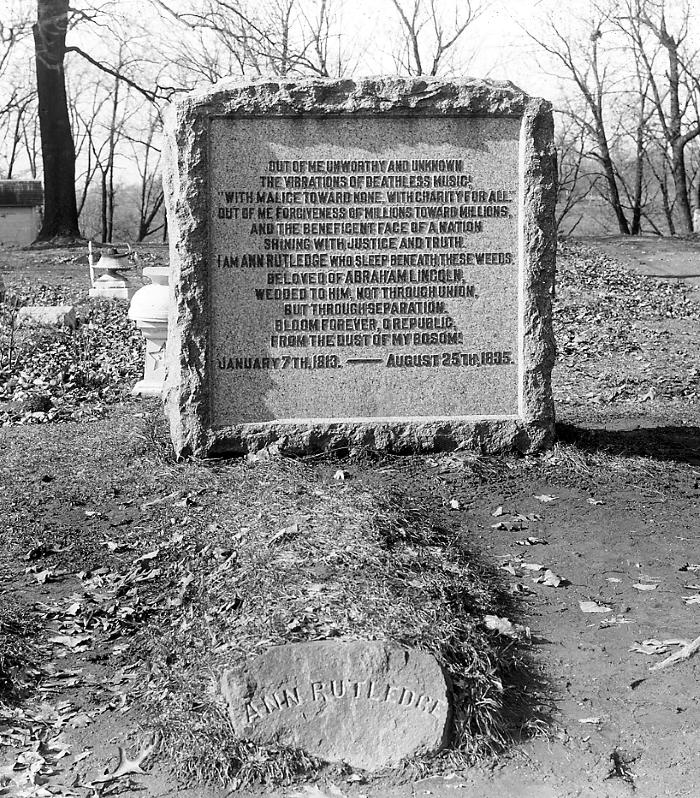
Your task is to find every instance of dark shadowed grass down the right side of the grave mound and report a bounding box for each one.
[365,468,553,760]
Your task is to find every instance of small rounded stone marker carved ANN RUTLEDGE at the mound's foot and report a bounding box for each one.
[222,640,450,771]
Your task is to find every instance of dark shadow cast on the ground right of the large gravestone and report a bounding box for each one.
[557,421,700,465]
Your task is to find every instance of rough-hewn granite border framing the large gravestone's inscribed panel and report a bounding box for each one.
[164,77,556,456]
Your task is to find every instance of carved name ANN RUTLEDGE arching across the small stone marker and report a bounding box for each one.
[245,679,447,723]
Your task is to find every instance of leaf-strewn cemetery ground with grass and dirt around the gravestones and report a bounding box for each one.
[0,242,700,798]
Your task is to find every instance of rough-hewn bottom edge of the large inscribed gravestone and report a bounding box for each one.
[206,419,554,456]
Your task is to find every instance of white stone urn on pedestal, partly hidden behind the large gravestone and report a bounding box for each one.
[129,266,170,396]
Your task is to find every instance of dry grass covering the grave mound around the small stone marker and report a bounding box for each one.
[129,459,544,784]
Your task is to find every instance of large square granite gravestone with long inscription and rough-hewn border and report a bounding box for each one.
[166,78,556,455]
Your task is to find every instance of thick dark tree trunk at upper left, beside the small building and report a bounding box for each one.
[33,0,80,241]
